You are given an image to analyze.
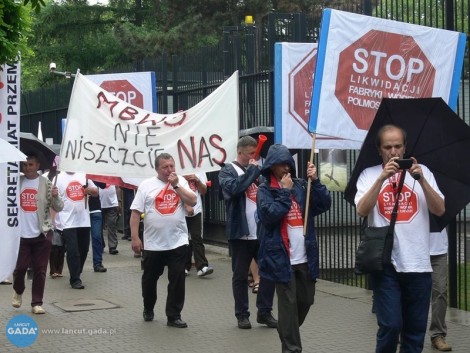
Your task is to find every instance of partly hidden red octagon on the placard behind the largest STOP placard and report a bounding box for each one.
[288,48,317,130]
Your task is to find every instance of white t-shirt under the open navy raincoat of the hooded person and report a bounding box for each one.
[287,199,307,265]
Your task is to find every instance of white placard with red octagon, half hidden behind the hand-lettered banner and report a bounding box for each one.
[86,71,157,112]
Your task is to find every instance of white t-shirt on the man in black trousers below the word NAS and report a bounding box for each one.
[131,176,189,251]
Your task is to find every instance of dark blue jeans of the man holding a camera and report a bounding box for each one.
[370,265,432,353]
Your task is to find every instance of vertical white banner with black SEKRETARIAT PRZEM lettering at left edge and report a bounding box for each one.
[0,63,21,281]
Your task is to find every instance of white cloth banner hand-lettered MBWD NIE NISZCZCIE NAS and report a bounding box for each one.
[59,72,239,178]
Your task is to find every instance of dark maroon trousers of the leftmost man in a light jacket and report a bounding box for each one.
[13,231,52,306]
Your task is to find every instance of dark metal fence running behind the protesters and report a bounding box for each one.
[21,0,470,310]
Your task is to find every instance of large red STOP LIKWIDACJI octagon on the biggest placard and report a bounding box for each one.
[335,30,436,130]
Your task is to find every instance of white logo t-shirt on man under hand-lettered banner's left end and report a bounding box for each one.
[56,172,96,230]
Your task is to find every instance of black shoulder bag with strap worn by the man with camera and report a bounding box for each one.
[354,172,406,275]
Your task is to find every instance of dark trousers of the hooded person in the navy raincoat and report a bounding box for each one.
[276,263,315,353]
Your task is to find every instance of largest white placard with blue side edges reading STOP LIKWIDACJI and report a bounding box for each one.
[309,9,466,142]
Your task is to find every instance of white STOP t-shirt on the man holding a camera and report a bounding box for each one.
[354,165,444,272]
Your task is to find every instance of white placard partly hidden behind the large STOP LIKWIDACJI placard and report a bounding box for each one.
[274,43,361,149]
